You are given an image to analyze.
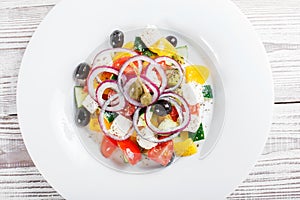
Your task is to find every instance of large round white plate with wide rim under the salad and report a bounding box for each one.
[17,0,273,199]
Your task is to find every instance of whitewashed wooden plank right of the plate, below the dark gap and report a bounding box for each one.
[229,104,300,200]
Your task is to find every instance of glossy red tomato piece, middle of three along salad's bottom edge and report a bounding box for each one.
[118,139,142,165]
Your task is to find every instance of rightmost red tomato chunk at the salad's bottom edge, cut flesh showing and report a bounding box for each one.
[148,140,174,166]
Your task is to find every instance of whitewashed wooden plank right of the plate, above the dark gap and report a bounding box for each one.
[233,0,300,102]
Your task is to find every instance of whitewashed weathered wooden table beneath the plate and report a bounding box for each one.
[0,0,300,200]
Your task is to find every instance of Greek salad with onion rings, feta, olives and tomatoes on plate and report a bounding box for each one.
[73,28,213,166]
